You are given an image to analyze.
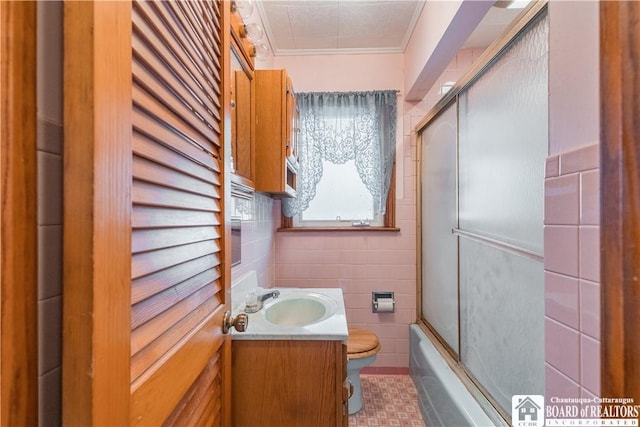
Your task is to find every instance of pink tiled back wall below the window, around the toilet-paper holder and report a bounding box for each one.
[276,231,416,367]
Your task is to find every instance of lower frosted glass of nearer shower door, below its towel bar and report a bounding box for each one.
[460,238,545,413]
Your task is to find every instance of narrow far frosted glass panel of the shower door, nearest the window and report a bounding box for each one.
[422,105,458,352]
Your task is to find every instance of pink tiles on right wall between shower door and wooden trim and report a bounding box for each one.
[544,144,600,398]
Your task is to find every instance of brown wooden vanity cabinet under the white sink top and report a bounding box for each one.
[232,340,349,427]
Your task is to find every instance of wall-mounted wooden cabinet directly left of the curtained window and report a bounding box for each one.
[255,70,299,197]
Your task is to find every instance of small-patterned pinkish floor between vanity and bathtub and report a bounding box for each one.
[349,375,425,427]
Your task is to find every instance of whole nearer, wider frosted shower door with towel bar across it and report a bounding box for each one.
[459,12,548,409]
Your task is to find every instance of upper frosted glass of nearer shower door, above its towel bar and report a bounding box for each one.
[459,15,548,253]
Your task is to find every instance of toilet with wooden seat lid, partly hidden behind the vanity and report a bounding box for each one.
[347,328,380,415]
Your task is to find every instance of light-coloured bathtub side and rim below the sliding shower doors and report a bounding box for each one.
[409,324,504,427]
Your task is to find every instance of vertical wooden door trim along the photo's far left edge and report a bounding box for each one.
[0,1,38,426]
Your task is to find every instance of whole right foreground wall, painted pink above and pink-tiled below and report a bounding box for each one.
[544,0,601,399]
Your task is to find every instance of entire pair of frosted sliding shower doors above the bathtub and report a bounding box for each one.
[420,9,548,414]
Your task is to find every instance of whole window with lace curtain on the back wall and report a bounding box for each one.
[282,91,396,229]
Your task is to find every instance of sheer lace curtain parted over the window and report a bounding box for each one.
[282,90,396,217]
